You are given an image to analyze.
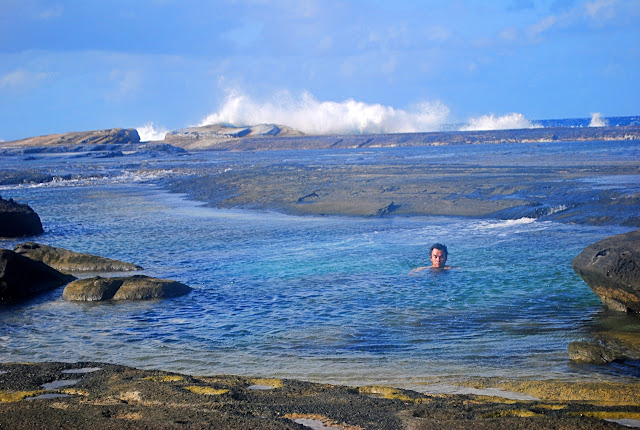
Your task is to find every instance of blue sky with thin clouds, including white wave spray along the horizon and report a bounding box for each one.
[0,0,640,141]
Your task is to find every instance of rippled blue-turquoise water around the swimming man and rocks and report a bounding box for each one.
[0,131,640,389]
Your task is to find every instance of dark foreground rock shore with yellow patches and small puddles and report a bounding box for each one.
[0,363,640,430]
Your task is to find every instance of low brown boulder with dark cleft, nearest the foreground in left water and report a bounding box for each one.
[62,275,192,302]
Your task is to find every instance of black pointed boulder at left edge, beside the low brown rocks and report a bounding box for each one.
[0,249,76,300]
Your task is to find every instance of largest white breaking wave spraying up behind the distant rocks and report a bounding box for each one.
[199,91,449,134]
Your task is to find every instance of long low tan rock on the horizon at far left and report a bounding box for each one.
[1,128,140,147]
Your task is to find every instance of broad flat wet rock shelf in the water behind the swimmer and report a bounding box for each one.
[168,154,640,226]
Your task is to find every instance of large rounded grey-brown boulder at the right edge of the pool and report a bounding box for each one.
[571,230,640,313]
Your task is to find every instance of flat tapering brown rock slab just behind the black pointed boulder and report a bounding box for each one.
[13,242,142,272]
